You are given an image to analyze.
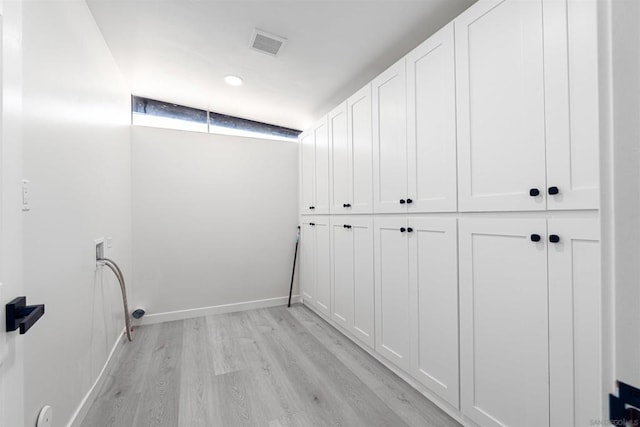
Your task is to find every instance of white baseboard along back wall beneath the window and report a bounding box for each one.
[134,295,301,326]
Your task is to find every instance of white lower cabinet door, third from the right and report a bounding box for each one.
[409,218,459,408]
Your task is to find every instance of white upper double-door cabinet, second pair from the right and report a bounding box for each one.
[372,24,457,213]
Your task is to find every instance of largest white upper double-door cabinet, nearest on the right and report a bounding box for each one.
[455,0,598,211]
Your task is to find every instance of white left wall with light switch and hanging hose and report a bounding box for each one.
[21,0,132,426]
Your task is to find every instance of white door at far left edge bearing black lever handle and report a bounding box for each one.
[0,0,25,426]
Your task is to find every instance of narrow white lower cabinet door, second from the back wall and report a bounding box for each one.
[314,216,331,317]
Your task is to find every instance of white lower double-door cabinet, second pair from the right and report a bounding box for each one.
[374,217,459,396]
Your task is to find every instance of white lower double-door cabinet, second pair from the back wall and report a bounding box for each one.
[331,216,374,348]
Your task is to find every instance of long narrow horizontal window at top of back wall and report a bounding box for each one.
[131,96,301,142]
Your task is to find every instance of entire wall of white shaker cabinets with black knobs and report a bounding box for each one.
[300,0,605,427]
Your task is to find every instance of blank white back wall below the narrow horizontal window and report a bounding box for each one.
[131,126,298,314]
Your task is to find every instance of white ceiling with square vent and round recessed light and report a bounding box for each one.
[87,0,475,129]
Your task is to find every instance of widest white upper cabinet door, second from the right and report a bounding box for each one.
[455,0,546,211]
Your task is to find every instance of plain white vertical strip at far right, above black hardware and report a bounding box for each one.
[603,0,640,387]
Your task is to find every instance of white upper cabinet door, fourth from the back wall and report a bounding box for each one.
[347,85,373,213]
